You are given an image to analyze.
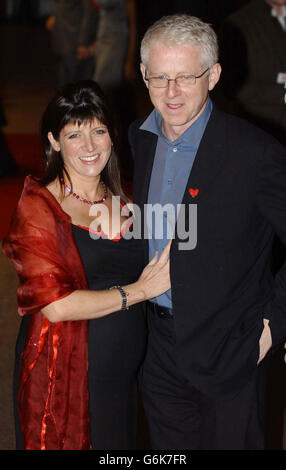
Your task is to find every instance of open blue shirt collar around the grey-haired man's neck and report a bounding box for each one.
[140,98,213,148]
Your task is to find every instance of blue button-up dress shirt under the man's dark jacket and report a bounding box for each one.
[140,99,213,308]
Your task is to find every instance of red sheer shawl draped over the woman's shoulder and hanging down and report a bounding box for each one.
[3,176,90,450]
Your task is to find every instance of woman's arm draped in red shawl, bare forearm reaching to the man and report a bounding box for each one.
[2,177,171,322]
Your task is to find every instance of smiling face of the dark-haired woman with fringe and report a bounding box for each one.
[48,118,112,177]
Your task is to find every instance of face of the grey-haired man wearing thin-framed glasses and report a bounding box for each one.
[141,41,221,140]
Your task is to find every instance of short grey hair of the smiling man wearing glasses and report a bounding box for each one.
[140,14,218,67]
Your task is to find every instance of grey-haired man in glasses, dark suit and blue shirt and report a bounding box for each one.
[129,15,286,449]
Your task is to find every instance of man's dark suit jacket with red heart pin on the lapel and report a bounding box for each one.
[129,108,286,394]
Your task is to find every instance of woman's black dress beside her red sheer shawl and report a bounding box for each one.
[73,225,146,450]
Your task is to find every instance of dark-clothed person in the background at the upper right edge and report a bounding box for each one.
[220,0,286,144]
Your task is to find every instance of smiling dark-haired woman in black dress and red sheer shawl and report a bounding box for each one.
[3,81,170,450]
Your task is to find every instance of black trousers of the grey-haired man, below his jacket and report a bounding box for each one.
[142,302,268,450]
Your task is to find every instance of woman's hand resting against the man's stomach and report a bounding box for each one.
[136,240,172,300]
